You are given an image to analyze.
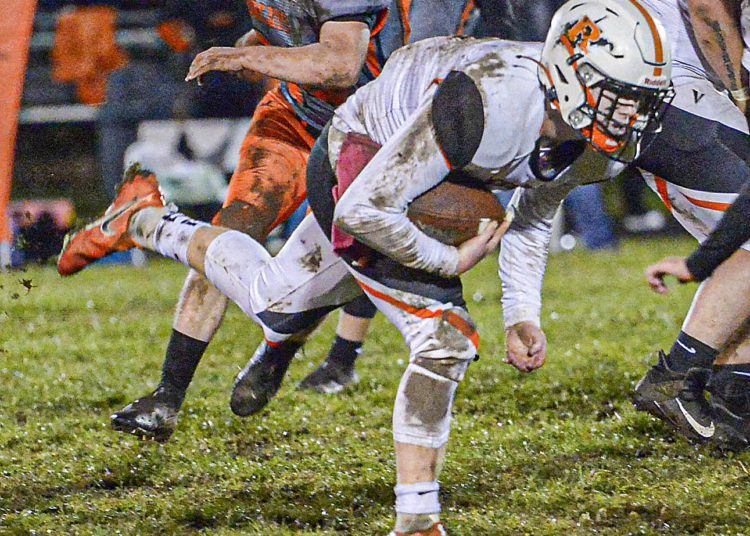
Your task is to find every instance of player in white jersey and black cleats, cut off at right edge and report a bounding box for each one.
[635,0,750,448]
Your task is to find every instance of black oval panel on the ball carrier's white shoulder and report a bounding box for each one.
[432,71,484,169]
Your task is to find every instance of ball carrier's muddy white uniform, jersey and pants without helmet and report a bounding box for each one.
[205,38,606,448]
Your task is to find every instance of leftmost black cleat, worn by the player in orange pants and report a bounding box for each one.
[110,385,185,443]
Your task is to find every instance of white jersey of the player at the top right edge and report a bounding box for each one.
[641,0,750,133]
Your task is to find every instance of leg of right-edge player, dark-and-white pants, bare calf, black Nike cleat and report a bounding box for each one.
[635,102,750,440]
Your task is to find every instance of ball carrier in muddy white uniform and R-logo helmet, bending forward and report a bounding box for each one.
[55,0,672,536]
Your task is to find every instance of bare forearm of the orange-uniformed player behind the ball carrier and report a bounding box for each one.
[185,21,370,89]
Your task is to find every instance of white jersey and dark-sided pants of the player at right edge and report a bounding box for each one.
[637,0,750,264]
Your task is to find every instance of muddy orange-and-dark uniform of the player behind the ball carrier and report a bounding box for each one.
[213,0,388,240]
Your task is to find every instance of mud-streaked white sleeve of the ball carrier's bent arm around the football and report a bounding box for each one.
[334,98,458,277]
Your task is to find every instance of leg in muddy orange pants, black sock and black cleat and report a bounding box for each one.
[112,92,312,439]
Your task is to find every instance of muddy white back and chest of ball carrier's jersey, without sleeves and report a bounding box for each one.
[332,37,544,167]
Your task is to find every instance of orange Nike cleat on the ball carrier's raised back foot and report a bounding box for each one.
[57,164,164,276]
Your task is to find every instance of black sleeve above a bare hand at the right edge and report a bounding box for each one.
[687,183,750,281]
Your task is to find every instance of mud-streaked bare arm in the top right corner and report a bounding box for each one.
[687,0,750,112]
